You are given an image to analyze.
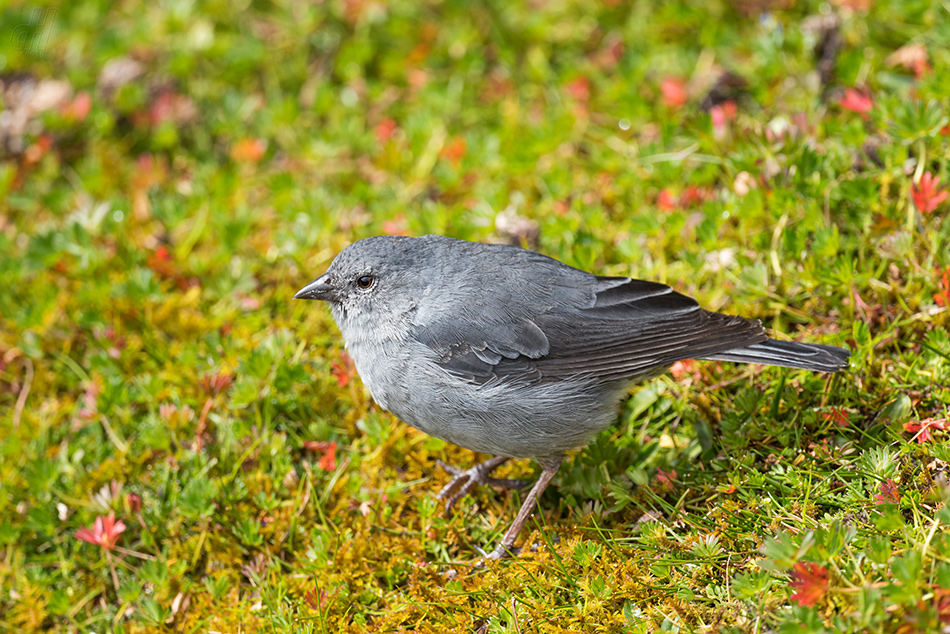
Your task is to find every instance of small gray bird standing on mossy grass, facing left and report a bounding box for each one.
[294,235,849,559]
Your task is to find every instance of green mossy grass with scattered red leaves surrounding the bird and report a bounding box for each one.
[0,0,950,633]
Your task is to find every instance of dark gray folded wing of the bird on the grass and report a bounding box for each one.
[414,267,768,383]
